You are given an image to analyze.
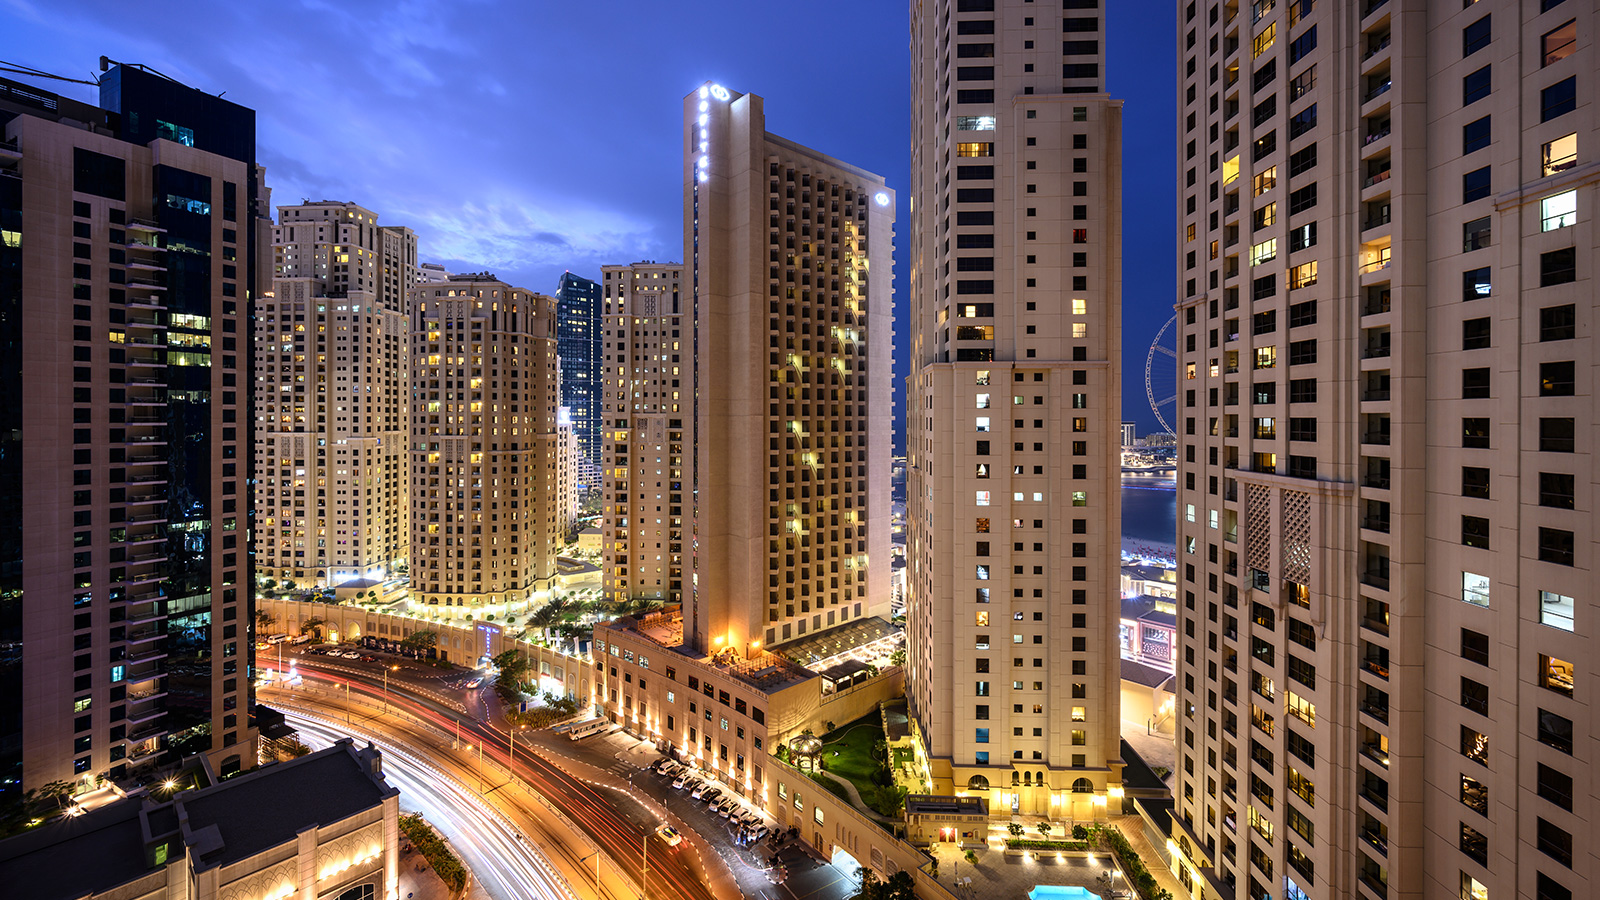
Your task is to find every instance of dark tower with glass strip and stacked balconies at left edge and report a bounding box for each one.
[0,66,267,793]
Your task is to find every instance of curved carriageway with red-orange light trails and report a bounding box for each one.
[262,668,722,900]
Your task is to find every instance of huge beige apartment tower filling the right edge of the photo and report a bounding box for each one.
[1173,0,1600,900]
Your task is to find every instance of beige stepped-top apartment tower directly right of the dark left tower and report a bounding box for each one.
[253,200,416,588]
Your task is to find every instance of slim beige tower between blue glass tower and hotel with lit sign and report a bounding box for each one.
[600,263,681,604]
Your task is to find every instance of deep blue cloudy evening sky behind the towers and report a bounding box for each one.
[0,0,1178,444]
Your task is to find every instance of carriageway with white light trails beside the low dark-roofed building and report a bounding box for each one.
[285,711,579,900]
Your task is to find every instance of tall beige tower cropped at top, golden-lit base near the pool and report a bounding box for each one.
[906,0,1122,818]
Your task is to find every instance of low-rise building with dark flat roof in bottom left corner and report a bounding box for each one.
[0,738,400,900]
